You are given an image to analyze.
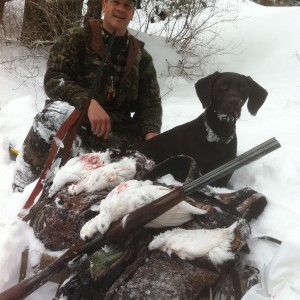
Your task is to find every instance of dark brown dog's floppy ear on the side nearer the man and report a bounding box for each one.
[195,72,220,108]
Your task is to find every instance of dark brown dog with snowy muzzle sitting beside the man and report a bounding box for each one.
[140,72,268,186]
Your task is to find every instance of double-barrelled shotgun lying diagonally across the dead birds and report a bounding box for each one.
[0,138,280,300]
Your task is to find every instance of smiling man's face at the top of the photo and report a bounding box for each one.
[102,0,134,36]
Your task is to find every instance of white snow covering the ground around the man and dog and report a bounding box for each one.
[0,0,300,300]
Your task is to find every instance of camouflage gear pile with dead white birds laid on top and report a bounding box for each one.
[30,152,267,299]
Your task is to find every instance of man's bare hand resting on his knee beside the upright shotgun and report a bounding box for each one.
[88,99,111,139]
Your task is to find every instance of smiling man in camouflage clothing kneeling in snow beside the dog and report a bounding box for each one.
[13,0,162,191]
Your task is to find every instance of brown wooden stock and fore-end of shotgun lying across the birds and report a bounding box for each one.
[0,188,185,300]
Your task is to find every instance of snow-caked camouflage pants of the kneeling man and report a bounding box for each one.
[12,100,142,191]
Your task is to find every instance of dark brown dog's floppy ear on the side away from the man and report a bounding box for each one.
[247,76,268,116]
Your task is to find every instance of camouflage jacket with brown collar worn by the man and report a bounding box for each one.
[44,20,162,136]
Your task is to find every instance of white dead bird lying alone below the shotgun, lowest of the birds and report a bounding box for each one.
[148,222,238,265]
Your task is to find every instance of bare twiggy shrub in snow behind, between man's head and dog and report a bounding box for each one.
[134,0,238,78]
